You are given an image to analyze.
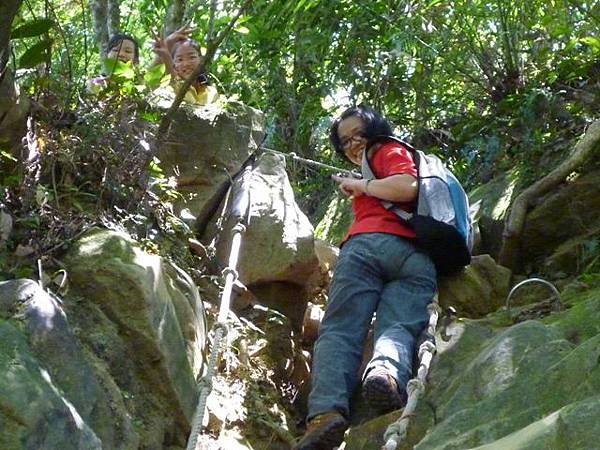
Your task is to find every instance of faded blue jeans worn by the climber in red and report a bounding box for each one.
[308,233,437,419]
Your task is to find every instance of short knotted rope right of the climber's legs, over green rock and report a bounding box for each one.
[382,292,441,450]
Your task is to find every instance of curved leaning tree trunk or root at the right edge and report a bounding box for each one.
[498,120,600,270]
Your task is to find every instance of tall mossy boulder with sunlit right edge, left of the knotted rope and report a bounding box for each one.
[64,229,206,450]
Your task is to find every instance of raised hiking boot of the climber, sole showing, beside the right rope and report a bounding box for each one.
[362,367,407,415]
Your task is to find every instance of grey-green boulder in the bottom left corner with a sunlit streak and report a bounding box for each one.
[0,280,123,450]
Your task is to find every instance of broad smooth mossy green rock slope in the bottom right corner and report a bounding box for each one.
[346,289,600,450]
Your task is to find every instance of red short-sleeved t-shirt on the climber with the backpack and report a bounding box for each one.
[344,142,417,241]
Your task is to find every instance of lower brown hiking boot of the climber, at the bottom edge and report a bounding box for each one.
[294,412,348,450]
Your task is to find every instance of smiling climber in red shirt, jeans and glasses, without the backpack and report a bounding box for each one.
[296,106,436,450]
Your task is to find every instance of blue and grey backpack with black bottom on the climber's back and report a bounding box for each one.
[361,136,473,275]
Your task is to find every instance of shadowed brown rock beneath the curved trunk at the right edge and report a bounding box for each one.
[521,171,600,275]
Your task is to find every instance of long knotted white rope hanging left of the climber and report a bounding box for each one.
[186,161,253,450]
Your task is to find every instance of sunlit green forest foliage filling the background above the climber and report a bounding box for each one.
[4,0,600,215]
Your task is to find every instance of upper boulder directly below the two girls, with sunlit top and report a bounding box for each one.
[158,103,264,222]
